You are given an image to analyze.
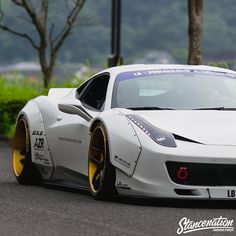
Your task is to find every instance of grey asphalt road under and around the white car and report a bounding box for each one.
[0,142,236,236]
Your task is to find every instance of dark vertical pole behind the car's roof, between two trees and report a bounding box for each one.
[108,0,122,67]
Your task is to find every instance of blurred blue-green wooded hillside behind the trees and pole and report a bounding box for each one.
[0,0,236,65]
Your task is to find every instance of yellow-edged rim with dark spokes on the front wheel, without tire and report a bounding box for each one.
[88,126,107,194]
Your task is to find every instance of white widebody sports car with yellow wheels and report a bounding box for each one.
[12,65,236,199]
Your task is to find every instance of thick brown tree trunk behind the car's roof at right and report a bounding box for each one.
[188,0,203,65]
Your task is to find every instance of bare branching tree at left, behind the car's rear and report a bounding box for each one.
[0,0,86,88]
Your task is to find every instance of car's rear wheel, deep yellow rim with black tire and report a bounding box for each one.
[12,116,42,185]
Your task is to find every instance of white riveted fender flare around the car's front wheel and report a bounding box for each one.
[90,109,142,177]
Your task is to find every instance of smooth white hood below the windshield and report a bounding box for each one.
[135,110,236,145]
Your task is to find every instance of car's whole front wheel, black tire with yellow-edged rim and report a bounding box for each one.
[88,122,117,200]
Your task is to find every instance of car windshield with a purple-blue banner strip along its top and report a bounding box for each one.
[112,70,236,110]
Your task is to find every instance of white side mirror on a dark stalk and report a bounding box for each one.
[58,100,93,121]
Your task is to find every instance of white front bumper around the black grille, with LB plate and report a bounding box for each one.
[116,139,236,200]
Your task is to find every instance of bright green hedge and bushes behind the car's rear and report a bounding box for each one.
[0,74,82,138]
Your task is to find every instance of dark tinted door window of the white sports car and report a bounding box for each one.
[80,74,109,110]
